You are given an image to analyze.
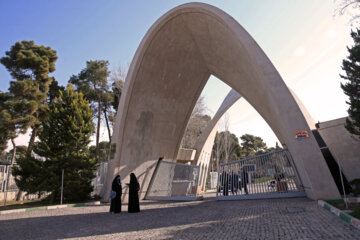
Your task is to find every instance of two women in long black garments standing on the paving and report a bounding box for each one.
[110,173,140,213]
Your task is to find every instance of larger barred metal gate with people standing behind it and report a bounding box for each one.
[216,150,306,200]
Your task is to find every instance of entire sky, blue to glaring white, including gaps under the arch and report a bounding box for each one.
[0,0,352,146]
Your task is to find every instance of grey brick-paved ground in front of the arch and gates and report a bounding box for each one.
[0,198,360,240]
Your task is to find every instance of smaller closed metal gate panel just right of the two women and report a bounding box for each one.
[146,161,200,200]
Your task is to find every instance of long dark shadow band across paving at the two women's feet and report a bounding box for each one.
[0,198,266,240]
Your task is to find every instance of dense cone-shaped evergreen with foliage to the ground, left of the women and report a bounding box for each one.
[14,84,96,202]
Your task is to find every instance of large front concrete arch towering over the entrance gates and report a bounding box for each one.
[105,3,339,199]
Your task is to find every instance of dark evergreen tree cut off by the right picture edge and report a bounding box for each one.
[340,29,360,139]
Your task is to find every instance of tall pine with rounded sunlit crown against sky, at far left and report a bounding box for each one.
[0,41,57,155]
